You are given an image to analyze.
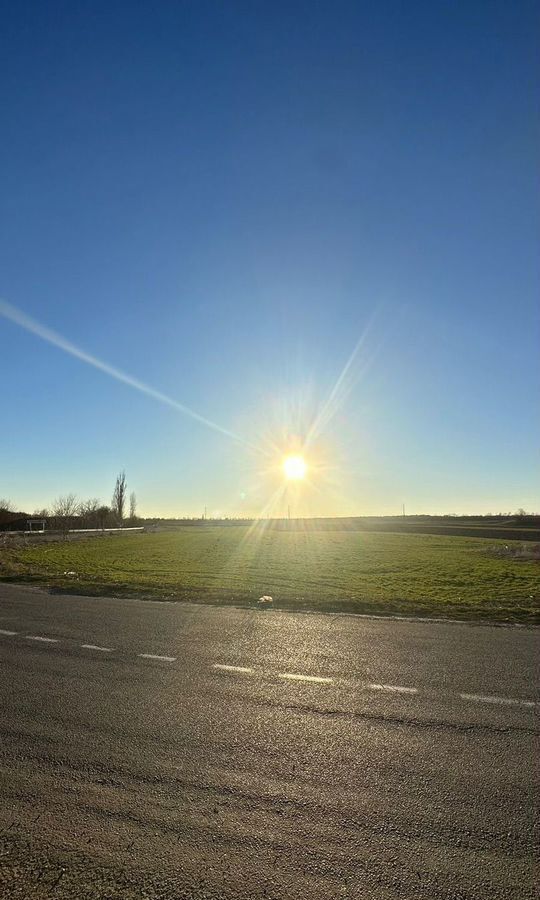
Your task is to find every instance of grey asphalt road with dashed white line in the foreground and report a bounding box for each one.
[0,585,540,900]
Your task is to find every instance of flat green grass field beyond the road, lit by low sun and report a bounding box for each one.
[0,525,540,623]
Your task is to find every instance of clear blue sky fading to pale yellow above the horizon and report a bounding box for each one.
[0,0,540,515]
